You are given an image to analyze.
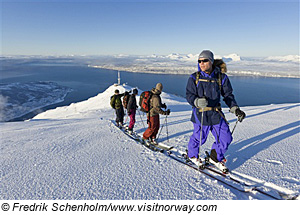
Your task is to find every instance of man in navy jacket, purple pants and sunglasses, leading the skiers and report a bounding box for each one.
[186,50,246,170]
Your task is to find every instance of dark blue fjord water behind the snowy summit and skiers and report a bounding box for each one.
[1,64,300,121]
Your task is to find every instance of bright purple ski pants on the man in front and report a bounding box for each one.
[188,119,232,161]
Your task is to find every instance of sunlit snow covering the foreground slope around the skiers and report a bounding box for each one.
[0,86,300,200]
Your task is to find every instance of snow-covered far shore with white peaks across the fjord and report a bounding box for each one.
[89,53,300,78]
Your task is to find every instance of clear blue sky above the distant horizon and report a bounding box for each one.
[1,0,299,57]
